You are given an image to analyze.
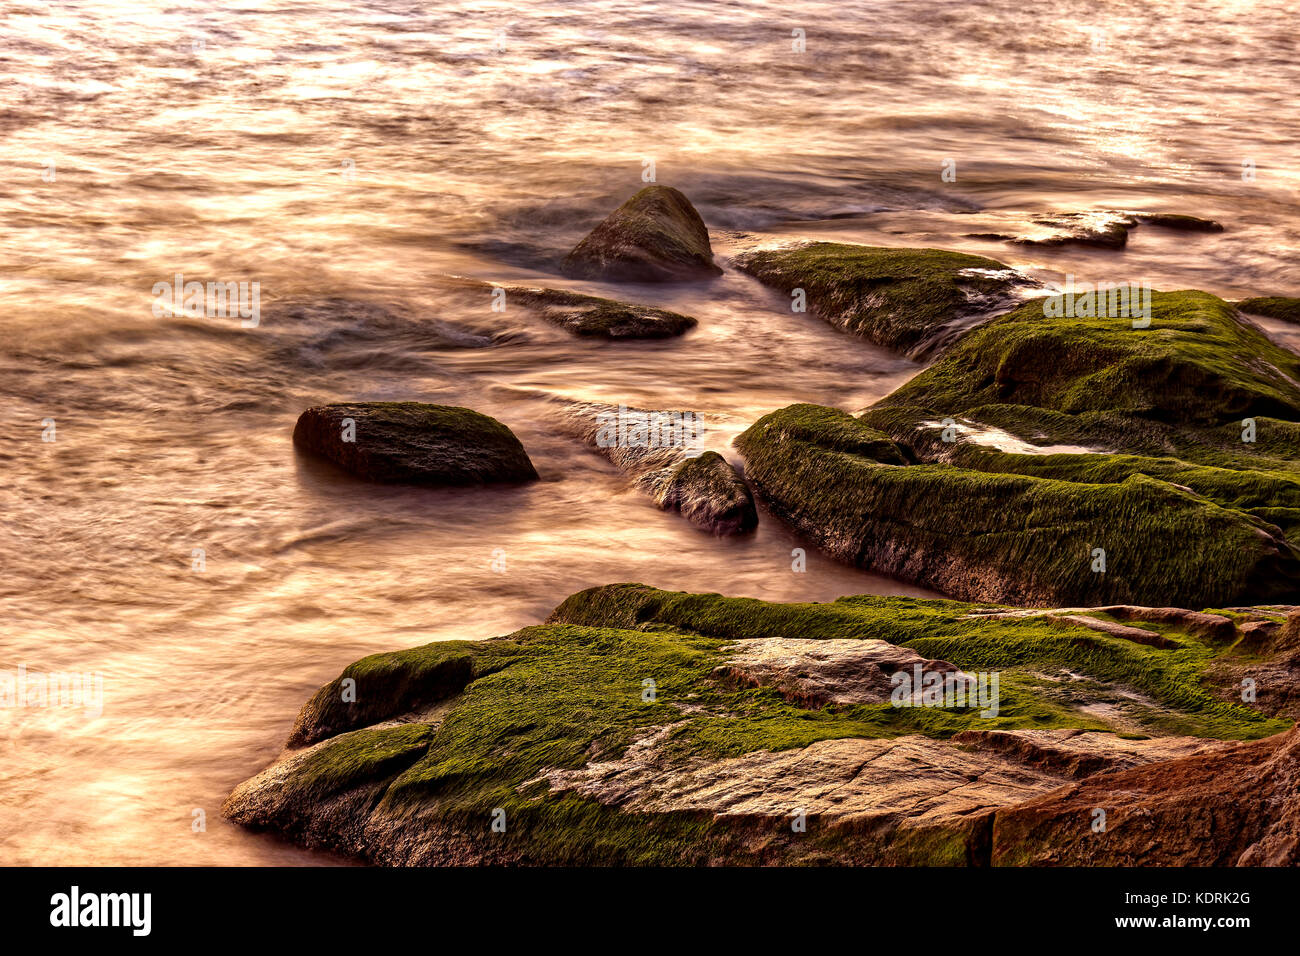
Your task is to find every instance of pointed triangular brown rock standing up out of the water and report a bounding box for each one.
[560,186,722,282]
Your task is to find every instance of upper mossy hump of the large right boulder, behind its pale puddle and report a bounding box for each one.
[866,291,1300,468]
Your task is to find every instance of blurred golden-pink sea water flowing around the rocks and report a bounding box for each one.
[0,0,1300,864]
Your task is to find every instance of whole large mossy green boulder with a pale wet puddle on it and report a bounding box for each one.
[737,291,1300,606]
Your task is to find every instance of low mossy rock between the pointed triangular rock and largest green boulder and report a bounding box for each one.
[732,242,1031,358]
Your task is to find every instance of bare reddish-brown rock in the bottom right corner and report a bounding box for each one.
[991,730,1300,866]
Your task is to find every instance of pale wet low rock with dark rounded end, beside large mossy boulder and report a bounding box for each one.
[566,403,758,535]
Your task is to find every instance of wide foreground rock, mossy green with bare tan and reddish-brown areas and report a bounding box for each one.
[222,584,1300,865]
